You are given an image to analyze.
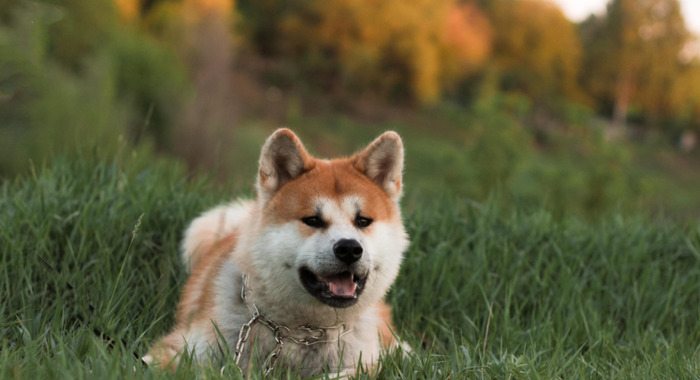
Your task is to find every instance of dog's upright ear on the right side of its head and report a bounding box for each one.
[352,132,403,201]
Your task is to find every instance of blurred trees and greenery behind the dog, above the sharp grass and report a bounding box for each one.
[0,0,700,220]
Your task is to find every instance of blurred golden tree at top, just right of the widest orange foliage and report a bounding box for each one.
[489,0,587,103]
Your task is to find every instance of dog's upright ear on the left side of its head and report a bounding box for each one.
[257,128,311,201]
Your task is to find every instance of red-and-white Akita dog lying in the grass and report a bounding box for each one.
[144,129,408,377]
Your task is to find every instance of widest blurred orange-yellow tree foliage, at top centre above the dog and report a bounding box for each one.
[240,0,491,103]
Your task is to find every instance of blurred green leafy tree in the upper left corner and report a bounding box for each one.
[0,0,189,166]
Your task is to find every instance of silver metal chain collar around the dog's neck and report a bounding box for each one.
[231,274,352,375]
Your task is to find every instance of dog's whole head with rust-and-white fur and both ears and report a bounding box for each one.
[254,129,408,314]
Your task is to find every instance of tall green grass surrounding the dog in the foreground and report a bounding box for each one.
[0,157,700,379]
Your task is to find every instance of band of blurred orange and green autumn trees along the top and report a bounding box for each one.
[6,0,700,135]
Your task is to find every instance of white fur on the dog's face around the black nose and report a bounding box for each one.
[254,195,408,314]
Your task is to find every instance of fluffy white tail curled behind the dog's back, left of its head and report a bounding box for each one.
[182,202,252,273]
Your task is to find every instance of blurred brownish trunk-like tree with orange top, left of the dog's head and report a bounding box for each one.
[145,0,236,168]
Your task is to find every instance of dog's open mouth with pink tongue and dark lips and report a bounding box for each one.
[299,268,367,308]
